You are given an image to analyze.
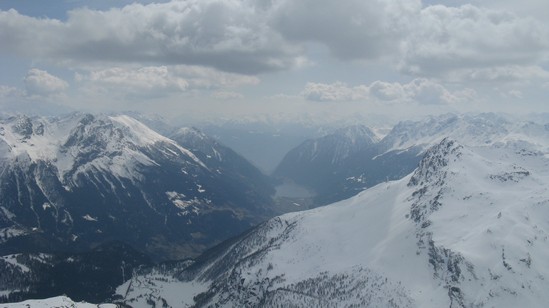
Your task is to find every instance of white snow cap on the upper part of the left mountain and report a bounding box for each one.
[0,113,207,189]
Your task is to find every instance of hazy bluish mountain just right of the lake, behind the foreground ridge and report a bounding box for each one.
[273,125,420,205]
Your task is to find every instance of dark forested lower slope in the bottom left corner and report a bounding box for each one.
[0,242,152,307]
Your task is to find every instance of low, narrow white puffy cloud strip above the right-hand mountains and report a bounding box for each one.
[301,78,476,104]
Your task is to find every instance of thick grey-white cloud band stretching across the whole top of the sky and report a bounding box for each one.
[0,0,549,82]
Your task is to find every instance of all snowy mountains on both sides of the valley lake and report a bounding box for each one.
[0,114,549,307]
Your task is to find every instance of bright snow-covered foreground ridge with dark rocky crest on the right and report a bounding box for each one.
[118,139,549,307]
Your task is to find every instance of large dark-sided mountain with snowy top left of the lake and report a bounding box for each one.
[0,114,272,259]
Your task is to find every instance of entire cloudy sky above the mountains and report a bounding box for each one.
[0,0,549,124]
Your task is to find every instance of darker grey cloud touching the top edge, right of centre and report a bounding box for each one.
[271,0,421,60]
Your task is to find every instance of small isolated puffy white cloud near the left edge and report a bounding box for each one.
[24,68,69,96]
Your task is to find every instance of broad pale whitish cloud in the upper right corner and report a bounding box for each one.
[400,5,549,77]
